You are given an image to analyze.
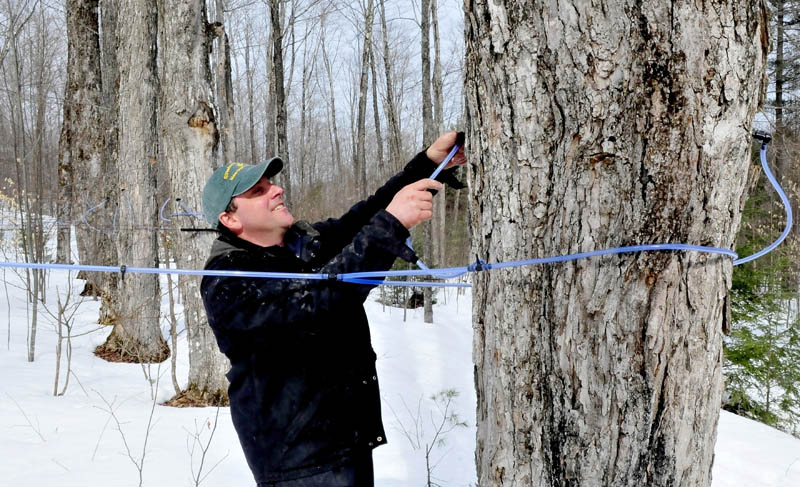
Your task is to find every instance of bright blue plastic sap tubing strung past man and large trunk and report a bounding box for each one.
[0,143,792,287]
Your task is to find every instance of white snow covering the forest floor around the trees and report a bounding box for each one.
[0,271,800,487]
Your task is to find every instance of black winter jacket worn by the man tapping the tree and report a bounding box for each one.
[201,152,462,482]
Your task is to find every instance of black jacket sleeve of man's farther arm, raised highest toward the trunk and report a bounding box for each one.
[313,151,463,262]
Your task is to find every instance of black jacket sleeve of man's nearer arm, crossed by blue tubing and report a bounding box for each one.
[201,211,408,353]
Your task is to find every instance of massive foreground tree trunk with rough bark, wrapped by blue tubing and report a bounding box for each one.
[465,0,768,486]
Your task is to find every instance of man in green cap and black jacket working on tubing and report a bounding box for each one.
[201,132,465,487]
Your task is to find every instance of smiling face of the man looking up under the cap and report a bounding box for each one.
[220,177,294,246]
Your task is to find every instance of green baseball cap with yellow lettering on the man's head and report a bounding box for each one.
[203,157,283,227]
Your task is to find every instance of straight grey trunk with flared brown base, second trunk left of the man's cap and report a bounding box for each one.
[97,0,169,362]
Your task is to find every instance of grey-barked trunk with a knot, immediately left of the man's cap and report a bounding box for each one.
[159,0,230,400]
